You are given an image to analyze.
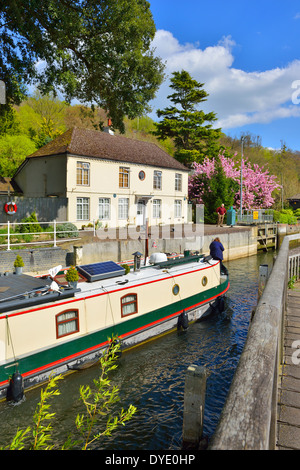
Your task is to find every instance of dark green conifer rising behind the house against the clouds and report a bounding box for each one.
[154,70,221,166]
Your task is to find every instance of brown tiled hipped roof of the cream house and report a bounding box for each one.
[27,127,188,171]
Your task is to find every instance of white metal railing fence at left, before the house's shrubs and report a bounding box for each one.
[0,220,88,251]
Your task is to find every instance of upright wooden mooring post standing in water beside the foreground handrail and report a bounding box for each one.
[183,364,206,447]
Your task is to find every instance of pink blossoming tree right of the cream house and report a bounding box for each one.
[189,154,280,209]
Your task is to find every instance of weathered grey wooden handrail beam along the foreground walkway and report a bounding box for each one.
[209,234,300,450]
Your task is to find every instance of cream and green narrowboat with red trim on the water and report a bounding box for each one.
[0,253,229,401]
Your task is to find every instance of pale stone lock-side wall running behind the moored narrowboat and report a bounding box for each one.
[0,228,257,273]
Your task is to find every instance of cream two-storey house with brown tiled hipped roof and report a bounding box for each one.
[14,128,189,227]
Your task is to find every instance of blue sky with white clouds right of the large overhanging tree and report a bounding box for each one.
[149,0,300,151]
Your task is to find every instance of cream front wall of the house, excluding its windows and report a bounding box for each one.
[67,156,188,227]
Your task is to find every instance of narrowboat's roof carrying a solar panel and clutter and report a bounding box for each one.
[0,255,219,315]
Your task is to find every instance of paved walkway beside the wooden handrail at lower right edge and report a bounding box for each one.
[277,282,300,450]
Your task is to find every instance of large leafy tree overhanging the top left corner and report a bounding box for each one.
[0,0,163,132]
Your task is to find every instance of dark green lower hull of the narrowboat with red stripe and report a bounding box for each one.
[0,279,229,399]
